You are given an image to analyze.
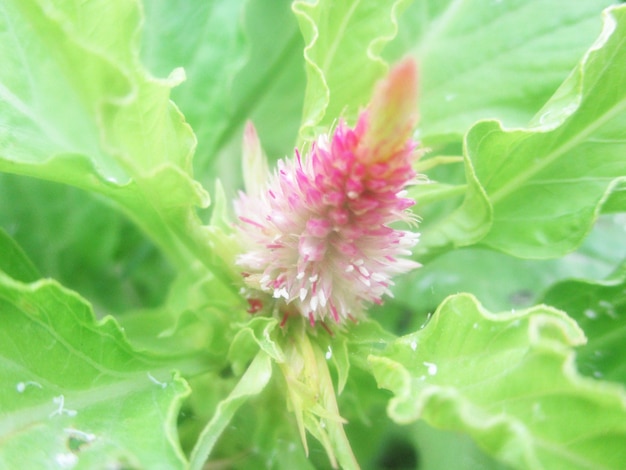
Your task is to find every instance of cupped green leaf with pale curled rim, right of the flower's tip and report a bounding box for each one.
[466,7,626,258]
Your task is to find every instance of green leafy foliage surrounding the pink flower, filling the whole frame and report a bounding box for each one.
[0,0,626,469]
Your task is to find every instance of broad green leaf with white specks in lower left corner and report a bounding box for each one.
[0,274,188,469]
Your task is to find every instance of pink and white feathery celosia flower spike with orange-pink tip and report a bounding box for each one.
[235,61,418,324]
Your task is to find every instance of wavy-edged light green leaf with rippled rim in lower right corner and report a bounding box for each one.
[370,294,626,469]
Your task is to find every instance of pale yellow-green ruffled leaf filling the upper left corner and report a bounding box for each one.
[0,0,208,266]
